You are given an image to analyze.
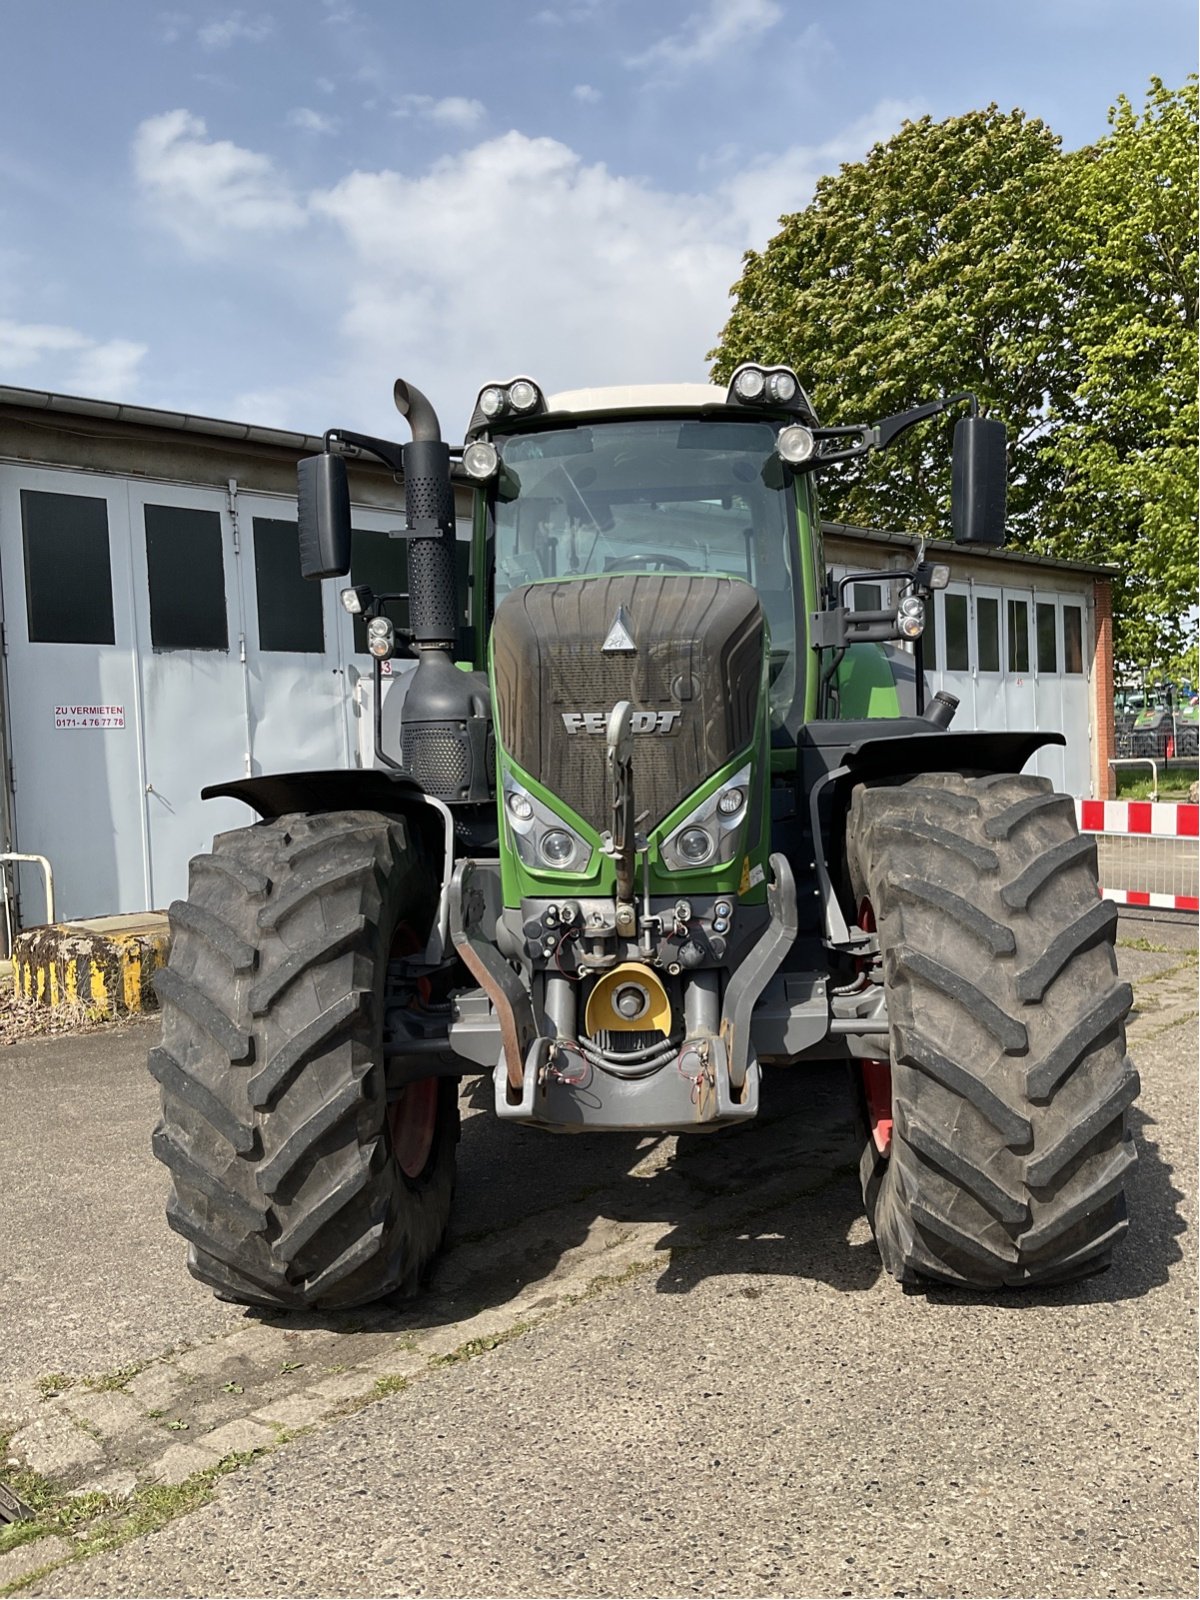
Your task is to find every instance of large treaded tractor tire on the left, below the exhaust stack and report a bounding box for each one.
[150,811,458,1309]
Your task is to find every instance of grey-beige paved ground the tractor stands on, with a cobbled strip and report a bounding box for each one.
[0,917,1197,1595]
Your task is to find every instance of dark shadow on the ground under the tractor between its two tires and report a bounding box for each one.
[414,1062,880,1320]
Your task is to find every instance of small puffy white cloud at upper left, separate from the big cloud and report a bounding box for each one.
[133,110,306,254]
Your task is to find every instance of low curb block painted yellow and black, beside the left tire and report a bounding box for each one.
[13,912,170,1016]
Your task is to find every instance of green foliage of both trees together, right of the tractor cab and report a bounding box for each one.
[710,80,1197,664]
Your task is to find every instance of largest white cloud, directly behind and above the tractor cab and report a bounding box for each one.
[310,104,910,430]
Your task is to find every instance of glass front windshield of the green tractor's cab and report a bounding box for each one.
[493,418,795,723]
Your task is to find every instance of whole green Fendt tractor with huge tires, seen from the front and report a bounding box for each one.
[150,363,1138,1309]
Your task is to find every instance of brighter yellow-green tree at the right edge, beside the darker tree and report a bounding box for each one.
[1046,77,1200,682]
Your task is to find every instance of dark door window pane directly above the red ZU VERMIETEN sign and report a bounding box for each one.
[21,490,117,645]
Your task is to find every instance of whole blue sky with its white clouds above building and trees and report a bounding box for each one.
[0,0,1197,437]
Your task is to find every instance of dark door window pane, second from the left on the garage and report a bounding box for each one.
[146,506,229,650]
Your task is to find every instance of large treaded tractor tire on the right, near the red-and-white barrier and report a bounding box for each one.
[846,773,1139,1290]
